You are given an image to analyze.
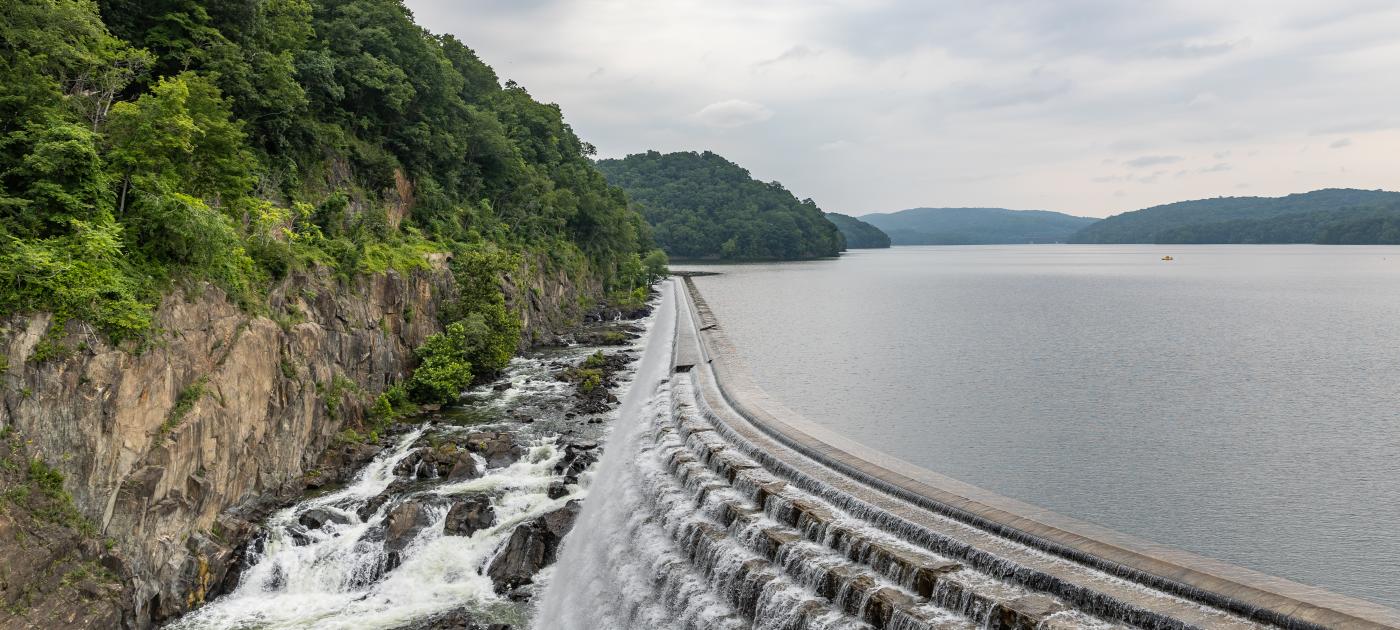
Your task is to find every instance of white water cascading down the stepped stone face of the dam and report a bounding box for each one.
[533,281,1282,630]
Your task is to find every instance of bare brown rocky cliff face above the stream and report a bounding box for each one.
[0,260,452,627]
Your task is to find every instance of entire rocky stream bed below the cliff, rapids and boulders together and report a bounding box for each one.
[167,295,660,630]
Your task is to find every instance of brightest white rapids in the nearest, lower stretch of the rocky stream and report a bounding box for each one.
[172,427,575,630]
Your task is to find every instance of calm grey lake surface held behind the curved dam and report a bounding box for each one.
[693,245,1400,608]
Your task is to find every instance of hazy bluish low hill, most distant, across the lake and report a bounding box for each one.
[861,207,1096,245]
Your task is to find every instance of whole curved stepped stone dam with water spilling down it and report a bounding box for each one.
[535,277,1400,630]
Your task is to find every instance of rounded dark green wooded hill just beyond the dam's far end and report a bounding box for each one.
[598,151,846,260]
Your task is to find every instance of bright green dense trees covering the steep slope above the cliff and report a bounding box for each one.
[0,0,664,398]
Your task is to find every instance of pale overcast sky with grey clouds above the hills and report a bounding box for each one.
[406,0,1400,217]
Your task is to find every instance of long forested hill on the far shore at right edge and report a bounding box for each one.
[1071,189,1400,245]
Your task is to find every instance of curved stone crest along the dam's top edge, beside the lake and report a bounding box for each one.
[678,277,1400,629]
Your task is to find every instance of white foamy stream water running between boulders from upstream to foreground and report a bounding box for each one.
[167,302,671,630]
